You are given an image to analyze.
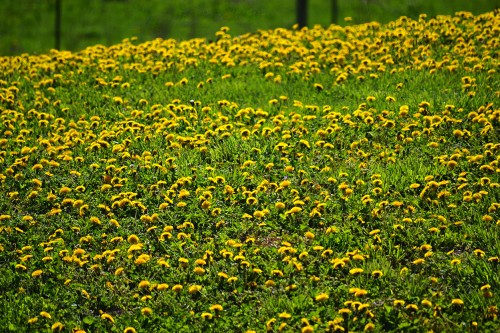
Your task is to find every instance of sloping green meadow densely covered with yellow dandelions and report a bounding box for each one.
[0,7,500,333]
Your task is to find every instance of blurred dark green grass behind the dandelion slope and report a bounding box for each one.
[0,0,500,56]
